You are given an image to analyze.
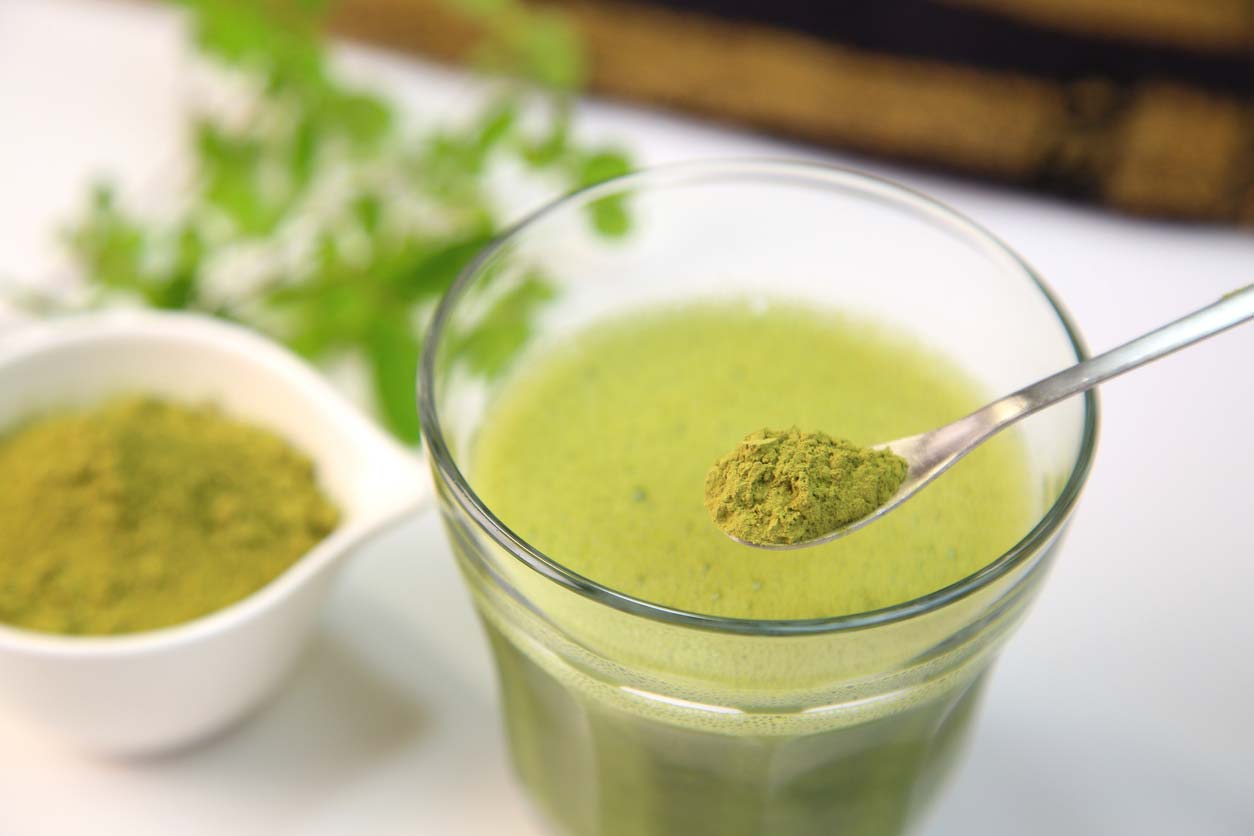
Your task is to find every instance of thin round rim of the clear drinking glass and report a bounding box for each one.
[419,158,1097,635]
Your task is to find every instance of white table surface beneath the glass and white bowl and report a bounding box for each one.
[0,0,1254,836]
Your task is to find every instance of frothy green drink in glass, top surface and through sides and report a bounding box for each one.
[461,302,1035,836]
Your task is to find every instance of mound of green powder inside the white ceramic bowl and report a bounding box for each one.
[0,397,340,635]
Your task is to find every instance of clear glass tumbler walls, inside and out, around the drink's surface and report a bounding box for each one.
[420,160,1097,836]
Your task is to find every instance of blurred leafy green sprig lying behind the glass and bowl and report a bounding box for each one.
[55,0,631,442]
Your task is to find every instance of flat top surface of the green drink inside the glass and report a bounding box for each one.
[473,303,1030,619]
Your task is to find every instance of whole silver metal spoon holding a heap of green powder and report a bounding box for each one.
[727,285,1254,551]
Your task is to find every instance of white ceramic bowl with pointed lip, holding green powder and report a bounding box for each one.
[0,312,429,755]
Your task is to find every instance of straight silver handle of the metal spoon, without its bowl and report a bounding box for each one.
[963,285,1254,437]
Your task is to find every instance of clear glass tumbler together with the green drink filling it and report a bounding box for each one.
[421,163,1093,836]
